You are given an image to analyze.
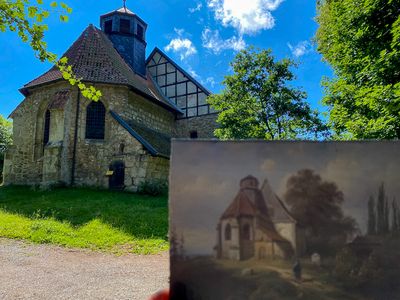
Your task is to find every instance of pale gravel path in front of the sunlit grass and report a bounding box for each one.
[0,239,169,300]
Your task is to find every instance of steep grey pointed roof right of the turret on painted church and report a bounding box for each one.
[261,180,296,223]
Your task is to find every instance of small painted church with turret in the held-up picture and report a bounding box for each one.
[214,176,305,260]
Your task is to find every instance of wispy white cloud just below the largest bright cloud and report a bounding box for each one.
[201,28,246,54]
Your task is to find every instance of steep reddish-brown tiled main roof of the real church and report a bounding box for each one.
[21,25,180,112]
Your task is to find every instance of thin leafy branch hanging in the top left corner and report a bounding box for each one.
[0,0,101,100]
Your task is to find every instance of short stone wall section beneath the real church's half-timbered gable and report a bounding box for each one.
[174,114,218,139]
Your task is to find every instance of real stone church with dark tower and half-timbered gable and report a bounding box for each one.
[4,7,216,191]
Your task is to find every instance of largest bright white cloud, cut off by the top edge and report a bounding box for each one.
[207,0,284,34]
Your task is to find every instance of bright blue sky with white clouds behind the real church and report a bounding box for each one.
[0,0,332,116]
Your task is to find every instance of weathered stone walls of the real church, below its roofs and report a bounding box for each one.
[4,78,216,190]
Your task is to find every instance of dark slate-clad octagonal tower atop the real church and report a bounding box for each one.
[100,4,147,77]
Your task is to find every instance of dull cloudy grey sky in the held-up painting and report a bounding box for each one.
[170,141,400,254]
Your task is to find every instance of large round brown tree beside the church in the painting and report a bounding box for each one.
[284,169,357,252]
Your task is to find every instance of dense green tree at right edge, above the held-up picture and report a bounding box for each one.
[316,0,400,139]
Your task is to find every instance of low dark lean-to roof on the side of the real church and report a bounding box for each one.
[110,111,171,158]
